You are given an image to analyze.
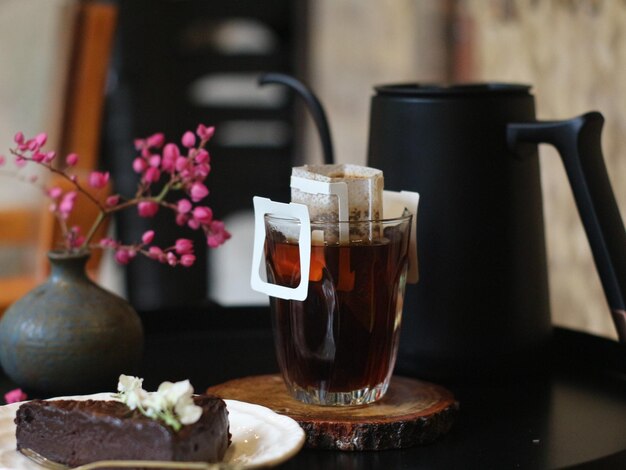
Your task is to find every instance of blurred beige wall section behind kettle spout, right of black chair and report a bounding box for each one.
[309,0,446,164]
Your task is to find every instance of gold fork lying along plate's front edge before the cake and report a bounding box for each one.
[20,448,241,470]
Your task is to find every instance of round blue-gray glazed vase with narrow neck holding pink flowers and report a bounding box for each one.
[0,251,143,394]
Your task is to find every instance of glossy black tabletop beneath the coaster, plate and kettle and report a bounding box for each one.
[0,305,626,470]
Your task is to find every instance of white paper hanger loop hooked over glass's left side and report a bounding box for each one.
[250,196,311,300]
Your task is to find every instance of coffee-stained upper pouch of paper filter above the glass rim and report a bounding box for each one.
[291,164,384,222]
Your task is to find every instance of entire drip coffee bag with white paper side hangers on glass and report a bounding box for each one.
[250,165,419,300]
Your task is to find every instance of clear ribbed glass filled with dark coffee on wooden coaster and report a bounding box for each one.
[264,214,412,405]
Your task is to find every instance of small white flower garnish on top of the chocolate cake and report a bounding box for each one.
[117,374,202,431]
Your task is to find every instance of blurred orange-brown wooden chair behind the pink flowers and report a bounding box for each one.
[0,1,117,313]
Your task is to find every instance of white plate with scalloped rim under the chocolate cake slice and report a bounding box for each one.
[0,393,304,470]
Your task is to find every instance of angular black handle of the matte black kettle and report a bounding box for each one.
[507,112,626,342]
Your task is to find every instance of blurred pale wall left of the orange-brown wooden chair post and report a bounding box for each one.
[0,0,75,207]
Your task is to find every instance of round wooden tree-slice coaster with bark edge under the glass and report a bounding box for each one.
[207,375,459,450]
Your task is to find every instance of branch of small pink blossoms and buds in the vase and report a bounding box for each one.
[0,124,230,266]
